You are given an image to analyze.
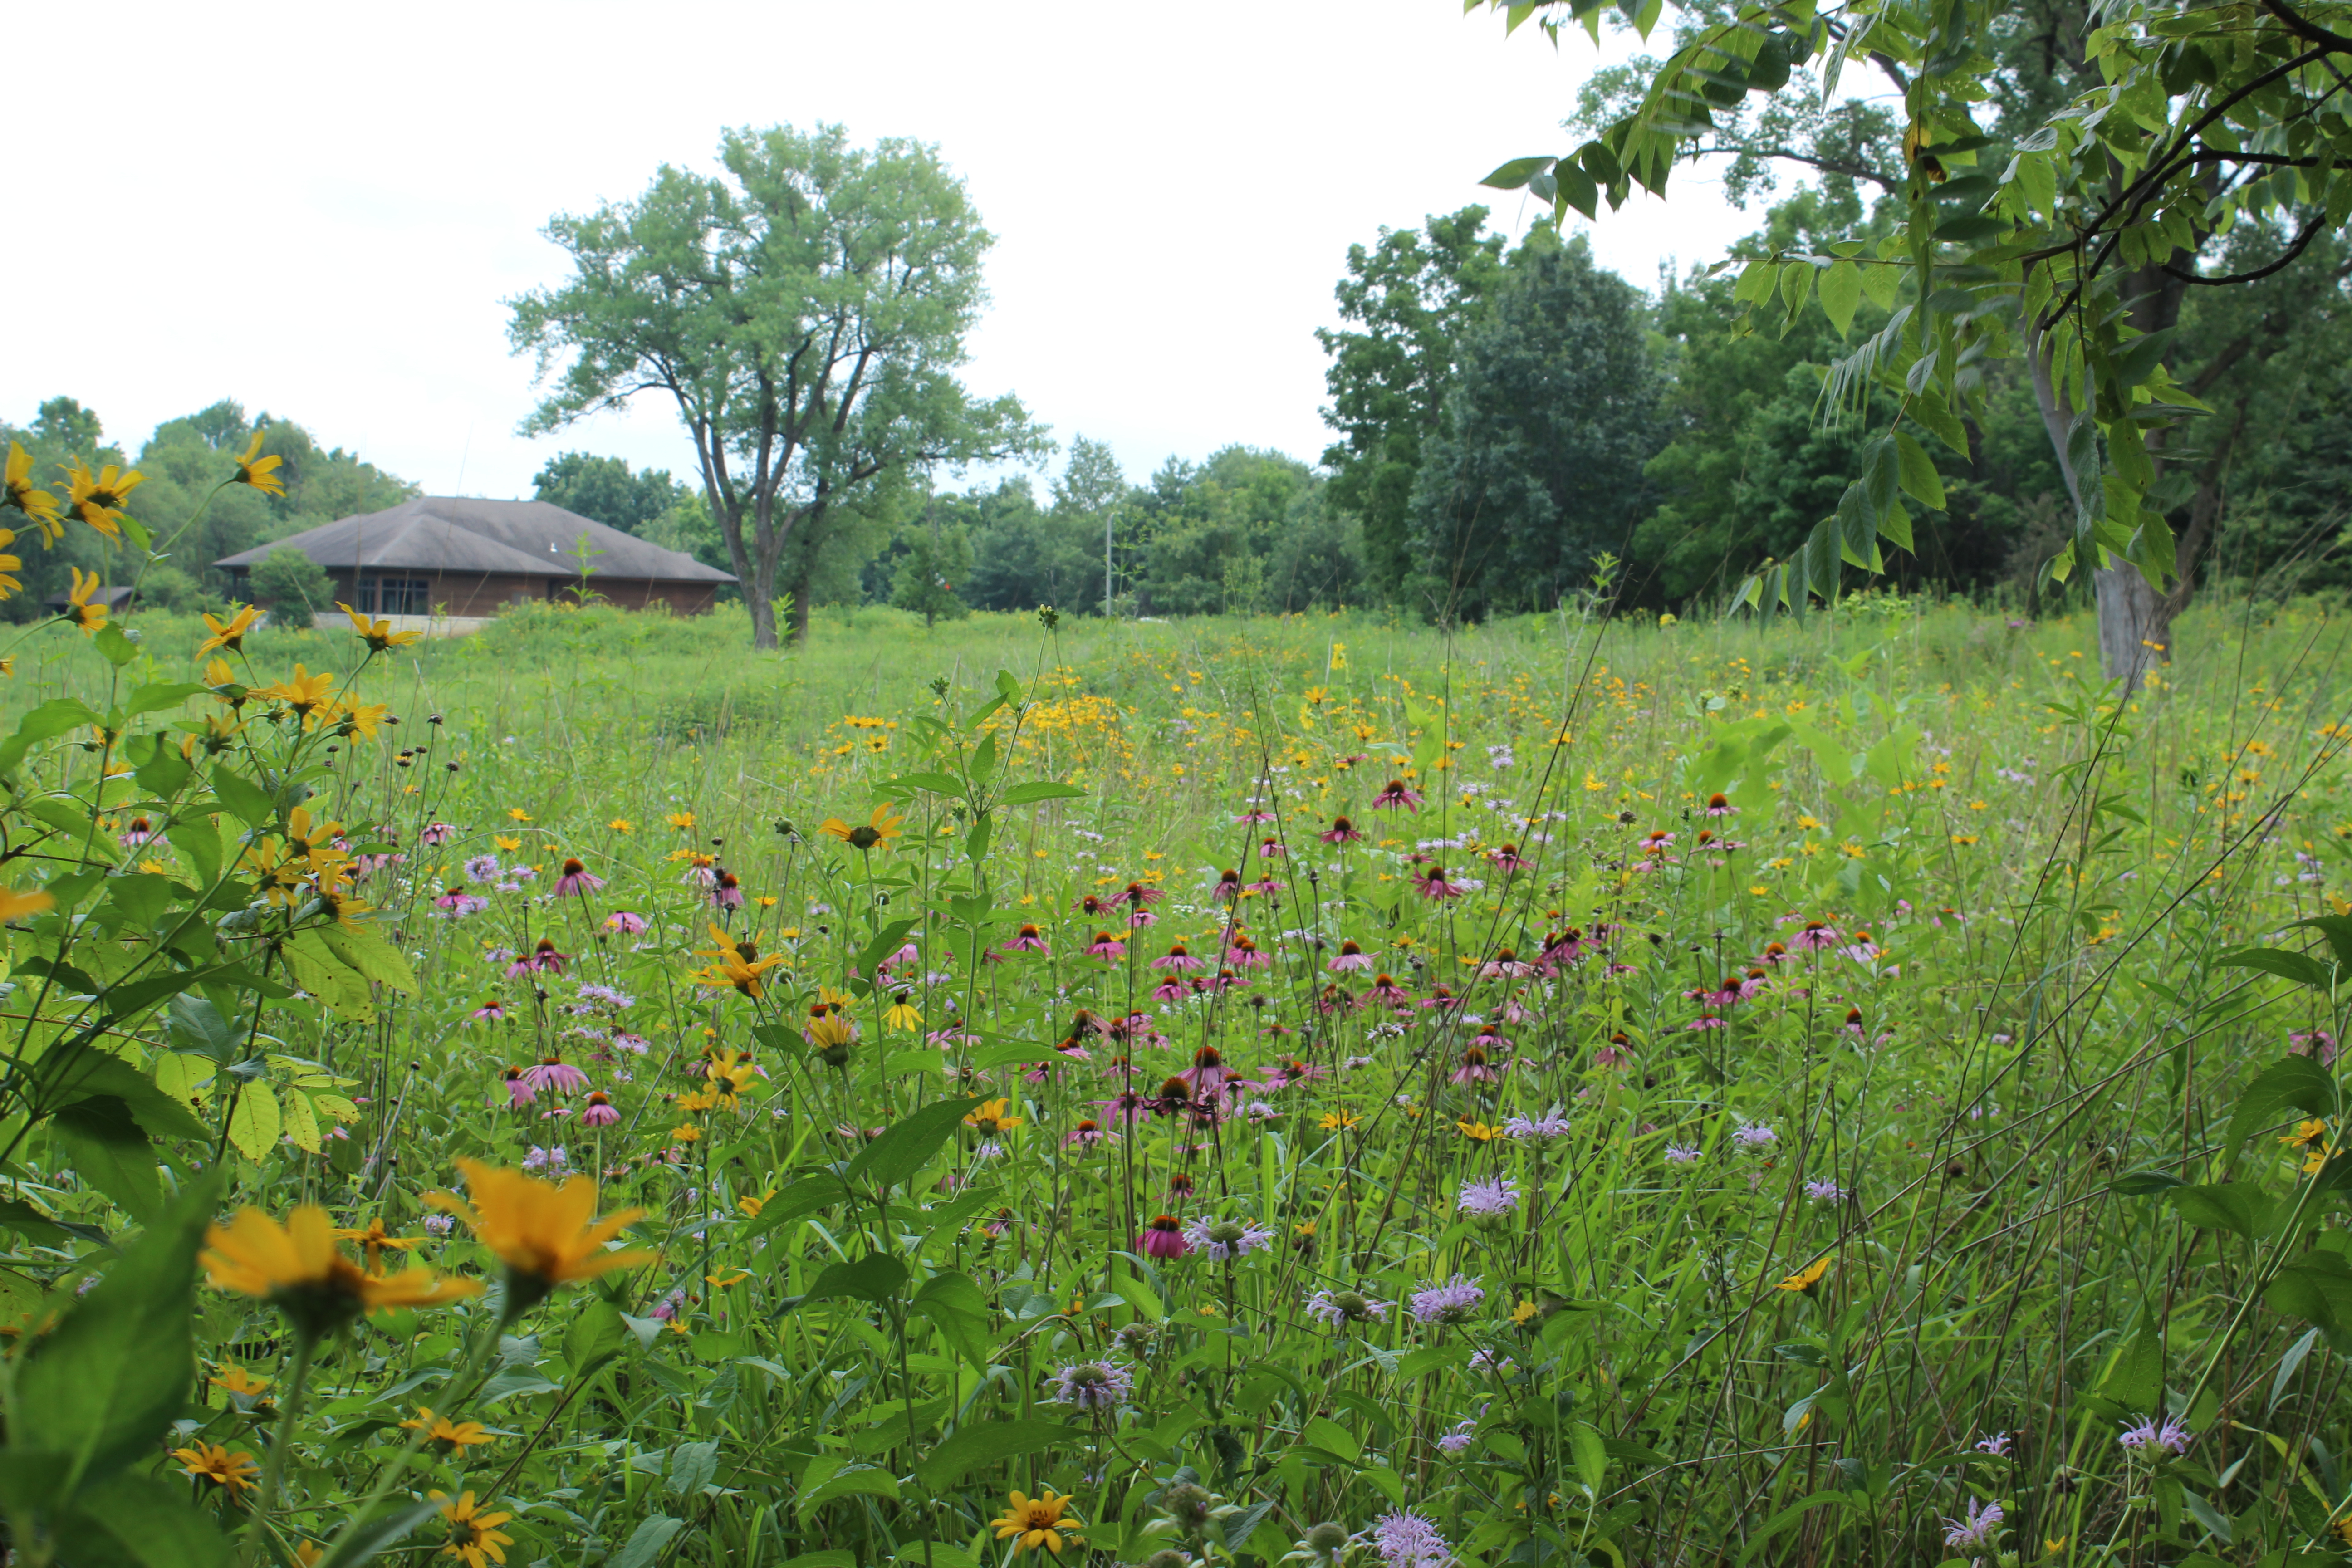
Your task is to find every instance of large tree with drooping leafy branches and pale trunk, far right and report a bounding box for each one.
[1489,0,2352,682]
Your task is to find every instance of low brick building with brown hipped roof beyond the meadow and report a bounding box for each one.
[214,496,736,621]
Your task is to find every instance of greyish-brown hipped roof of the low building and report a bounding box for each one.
[212,496,736,583]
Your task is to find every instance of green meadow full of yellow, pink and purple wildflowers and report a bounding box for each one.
[14,531,2352,1568]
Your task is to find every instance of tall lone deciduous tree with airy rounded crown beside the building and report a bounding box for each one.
[510,125,1044,649]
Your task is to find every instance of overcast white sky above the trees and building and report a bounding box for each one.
[0,0,1759,496]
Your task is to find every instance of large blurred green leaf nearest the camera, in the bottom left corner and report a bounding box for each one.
[16,1180,216,1502]
